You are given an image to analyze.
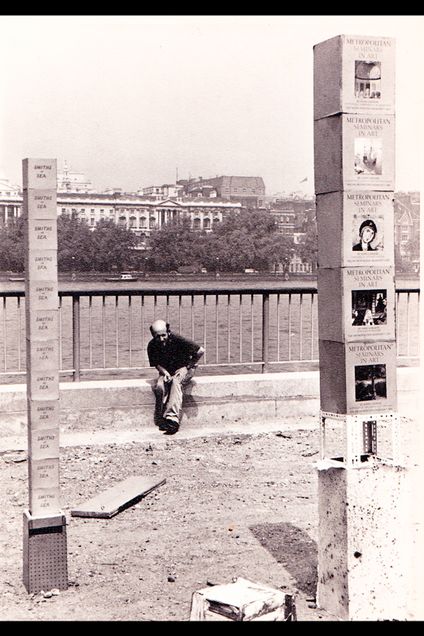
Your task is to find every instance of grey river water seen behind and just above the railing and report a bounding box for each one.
[0,275,419,382]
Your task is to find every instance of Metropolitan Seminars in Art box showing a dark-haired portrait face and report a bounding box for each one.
[316,191,395,269]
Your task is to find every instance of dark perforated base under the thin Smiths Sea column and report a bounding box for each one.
[23,513,68,593]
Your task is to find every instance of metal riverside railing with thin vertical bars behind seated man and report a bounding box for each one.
[0,286,420,382]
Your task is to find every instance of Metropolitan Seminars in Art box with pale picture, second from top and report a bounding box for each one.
[314,115,395,194]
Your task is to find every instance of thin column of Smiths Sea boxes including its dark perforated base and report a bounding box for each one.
[23,159,67,592]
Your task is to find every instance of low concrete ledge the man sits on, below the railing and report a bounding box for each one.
[0,367,419,436]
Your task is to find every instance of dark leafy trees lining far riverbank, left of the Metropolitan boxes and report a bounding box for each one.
[0,211,317,272]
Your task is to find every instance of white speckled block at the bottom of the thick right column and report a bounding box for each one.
[317,464,409,620]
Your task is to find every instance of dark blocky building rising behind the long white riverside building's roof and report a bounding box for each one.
[182,176,265,208]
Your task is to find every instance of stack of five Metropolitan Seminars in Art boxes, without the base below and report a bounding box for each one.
[314,36,396,459]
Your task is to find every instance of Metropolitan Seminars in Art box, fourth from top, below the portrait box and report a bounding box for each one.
[318,267,396,342]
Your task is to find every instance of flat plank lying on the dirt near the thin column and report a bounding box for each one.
[71,476,166,519]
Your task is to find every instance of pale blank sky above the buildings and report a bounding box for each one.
[0,16,424,194]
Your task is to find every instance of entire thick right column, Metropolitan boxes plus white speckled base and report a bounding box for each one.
[314,35,403,620]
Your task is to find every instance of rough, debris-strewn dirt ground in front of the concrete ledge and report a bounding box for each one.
[0,422,340,621]
